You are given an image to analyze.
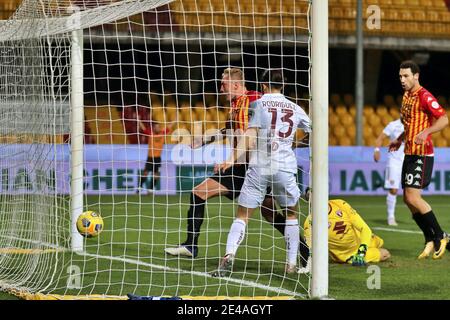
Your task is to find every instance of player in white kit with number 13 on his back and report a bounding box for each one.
[212,69,311,277]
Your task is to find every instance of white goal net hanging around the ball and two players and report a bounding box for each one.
[0,0,311,299]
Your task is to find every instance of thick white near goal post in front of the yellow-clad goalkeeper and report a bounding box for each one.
[311,0,329,298]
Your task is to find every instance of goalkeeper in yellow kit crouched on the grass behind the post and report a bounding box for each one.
[304,189,391,266]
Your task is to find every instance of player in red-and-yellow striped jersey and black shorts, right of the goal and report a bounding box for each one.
[389,61,449,259]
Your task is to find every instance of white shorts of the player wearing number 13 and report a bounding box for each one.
[238,167,300,209]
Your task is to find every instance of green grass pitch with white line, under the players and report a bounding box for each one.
[0,194,450,299]
